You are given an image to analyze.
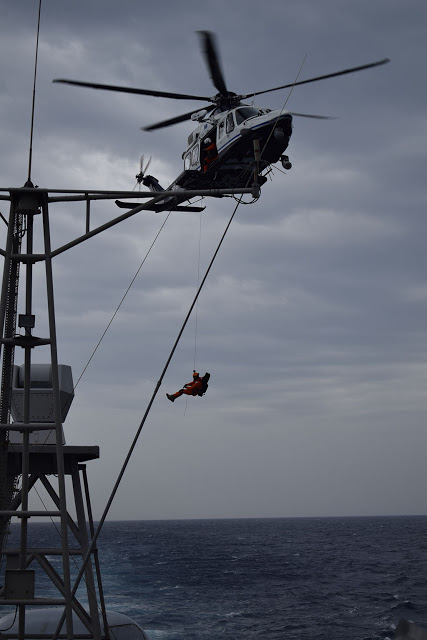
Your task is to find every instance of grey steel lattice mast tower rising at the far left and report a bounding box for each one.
[0,186,103,639]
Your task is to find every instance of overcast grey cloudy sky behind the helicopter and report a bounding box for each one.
[0,0,427,519]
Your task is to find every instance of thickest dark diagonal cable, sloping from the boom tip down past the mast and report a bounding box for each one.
[53,200,244,640]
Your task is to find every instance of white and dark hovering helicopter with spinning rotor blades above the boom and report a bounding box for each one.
[53,31,389,211]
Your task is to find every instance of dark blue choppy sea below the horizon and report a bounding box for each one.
[0,516,427,640]
